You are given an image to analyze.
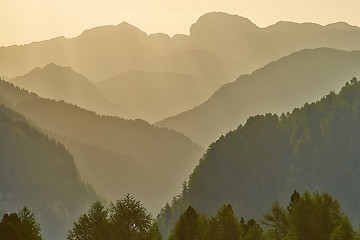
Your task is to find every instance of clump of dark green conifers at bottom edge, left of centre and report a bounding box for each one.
[67,194,162,240]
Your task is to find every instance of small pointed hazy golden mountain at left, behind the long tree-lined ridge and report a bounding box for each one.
[10,63,127,117]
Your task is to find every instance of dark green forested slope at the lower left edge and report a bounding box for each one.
[0,105,97,239]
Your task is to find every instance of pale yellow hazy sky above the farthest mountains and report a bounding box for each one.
[0,0,360,46]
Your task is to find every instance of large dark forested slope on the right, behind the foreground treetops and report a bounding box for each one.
[159,79,360,236]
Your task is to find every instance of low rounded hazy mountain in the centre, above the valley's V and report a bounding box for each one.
[96,71,216,121]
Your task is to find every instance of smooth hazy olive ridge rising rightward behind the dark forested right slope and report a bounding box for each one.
[156,48,360,146]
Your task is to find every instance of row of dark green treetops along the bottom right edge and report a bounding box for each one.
[169,191,360,240]
